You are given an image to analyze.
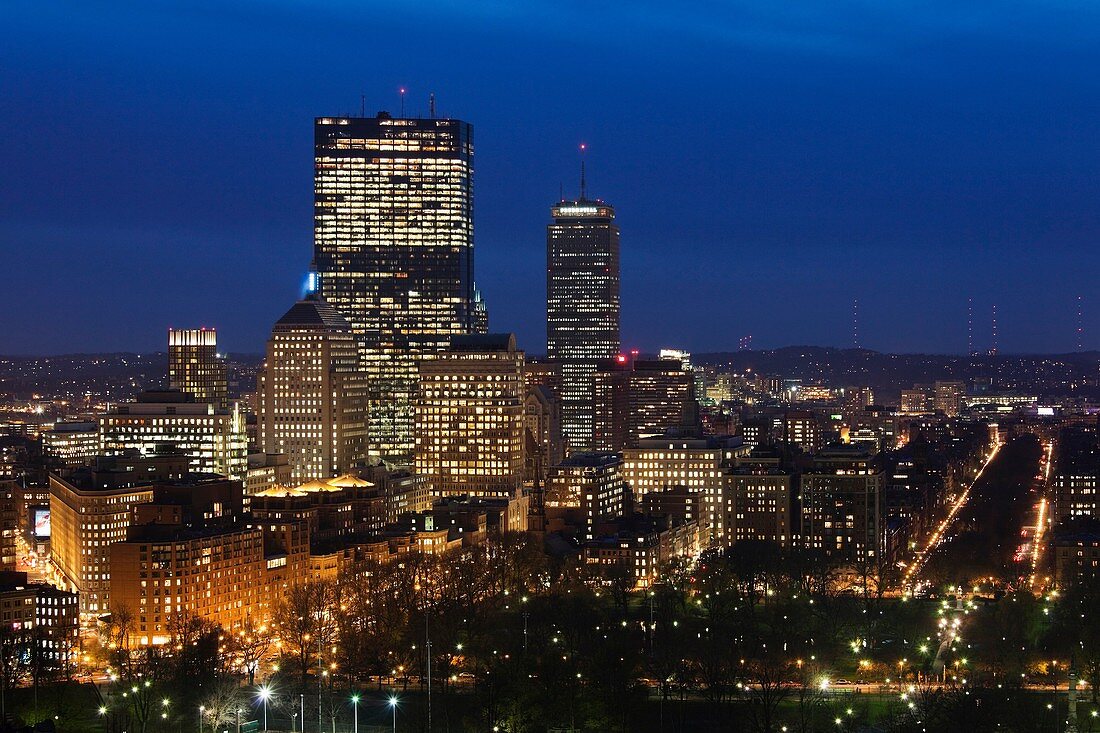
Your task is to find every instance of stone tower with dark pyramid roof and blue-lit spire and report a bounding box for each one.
[256,294,369,483]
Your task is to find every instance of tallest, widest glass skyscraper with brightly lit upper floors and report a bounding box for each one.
[314,112,482,460]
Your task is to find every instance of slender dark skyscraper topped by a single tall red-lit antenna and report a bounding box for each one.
[547,177,619,450]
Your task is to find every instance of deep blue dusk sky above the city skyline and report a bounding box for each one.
[0,0,1100,353]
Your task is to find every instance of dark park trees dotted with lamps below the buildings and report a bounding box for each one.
[85,535,1100,733]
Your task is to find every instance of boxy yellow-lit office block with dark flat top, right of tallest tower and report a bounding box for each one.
[416,333,527,497]
